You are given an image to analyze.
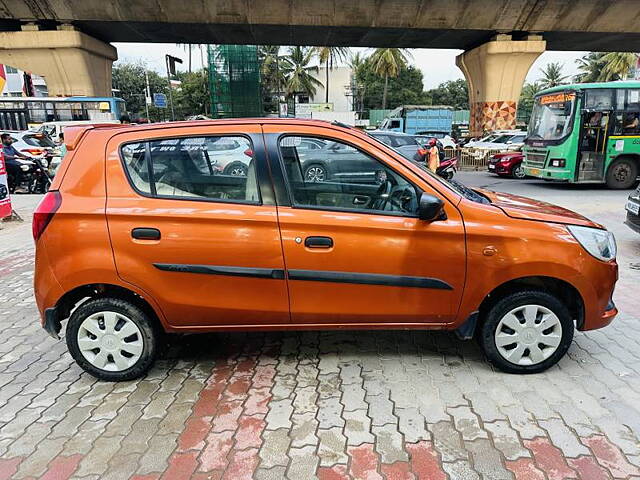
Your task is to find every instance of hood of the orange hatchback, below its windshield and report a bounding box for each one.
[476,189,604,229]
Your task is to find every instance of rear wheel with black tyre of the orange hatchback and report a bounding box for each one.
[66,298,160,381]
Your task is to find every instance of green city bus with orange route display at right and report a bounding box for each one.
[523,81,640,188]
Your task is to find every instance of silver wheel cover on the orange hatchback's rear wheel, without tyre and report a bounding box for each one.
[78,312,144,372]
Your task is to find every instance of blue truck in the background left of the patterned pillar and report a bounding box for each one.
[380,105,453,135]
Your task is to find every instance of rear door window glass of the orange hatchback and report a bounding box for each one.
[121,136,260,203]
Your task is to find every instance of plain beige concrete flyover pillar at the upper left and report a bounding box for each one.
[0,25,118,97]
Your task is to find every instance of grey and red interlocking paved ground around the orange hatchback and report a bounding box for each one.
[0,181,640,480]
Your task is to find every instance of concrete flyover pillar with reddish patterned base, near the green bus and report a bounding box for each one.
[456,35,546,135]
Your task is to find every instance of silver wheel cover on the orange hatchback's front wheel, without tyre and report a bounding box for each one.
[494,305,562,365]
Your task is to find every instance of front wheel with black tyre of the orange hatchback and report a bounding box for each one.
[478,290,574,373]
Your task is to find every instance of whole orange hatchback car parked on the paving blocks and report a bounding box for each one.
[33,119,618,380]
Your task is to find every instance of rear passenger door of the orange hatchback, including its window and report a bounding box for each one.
[106,125,289,329]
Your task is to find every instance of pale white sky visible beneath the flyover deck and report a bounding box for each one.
[113,43,587,90]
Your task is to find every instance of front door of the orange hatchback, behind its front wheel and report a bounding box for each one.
[264,125,465,326]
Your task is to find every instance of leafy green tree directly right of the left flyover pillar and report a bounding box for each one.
[112,62,169,120]
